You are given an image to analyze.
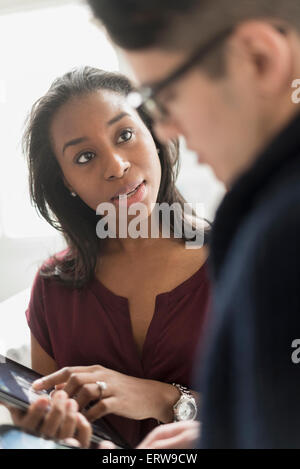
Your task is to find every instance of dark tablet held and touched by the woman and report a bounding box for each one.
[0,355,131,449]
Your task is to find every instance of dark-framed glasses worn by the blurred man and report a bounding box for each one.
[127,27,235,121]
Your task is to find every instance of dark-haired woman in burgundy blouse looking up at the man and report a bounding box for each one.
[11,67,209,446]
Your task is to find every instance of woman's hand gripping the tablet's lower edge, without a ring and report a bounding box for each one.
[7,391,92,447]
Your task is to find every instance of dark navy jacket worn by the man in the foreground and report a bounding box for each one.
[197,111,300,448]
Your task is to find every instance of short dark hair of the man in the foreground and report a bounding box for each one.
[88,0,300,74]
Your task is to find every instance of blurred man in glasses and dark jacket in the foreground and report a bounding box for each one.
[89,0,300,448]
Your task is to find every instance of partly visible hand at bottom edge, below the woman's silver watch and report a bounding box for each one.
[99,421,200,449]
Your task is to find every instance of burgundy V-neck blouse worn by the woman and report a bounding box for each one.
[26,258,210,446]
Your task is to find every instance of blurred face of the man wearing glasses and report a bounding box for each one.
[124,28,296,186]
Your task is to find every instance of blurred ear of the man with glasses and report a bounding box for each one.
[235,20,293,97]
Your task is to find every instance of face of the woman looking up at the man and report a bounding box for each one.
[50,90,161,215]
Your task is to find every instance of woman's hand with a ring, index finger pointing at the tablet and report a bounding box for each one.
[33,365,180,423]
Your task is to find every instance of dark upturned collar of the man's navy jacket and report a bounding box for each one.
[210,113,300,280]
